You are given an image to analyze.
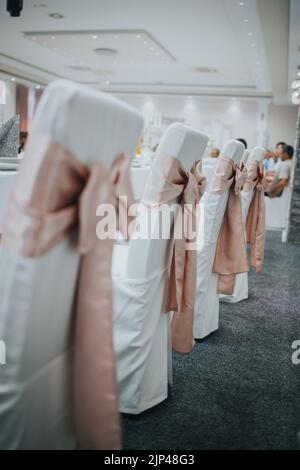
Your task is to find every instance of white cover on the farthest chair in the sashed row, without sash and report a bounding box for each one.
[219,147,265,303]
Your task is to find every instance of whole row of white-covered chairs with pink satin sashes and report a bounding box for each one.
[0,81,263,449]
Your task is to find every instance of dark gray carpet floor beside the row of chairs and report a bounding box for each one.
[122,233,300,450]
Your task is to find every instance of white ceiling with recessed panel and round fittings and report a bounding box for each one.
[0,0,300,101]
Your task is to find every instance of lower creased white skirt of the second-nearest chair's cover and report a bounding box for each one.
[113,269,170,414]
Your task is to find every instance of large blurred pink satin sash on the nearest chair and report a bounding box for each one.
[2,135,133,449]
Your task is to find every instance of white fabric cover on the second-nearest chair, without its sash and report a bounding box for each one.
[114,124,208,414]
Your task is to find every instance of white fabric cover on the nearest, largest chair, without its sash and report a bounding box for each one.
[0,81,142,449]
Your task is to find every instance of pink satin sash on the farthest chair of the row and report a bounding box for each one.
[244,161,267,272]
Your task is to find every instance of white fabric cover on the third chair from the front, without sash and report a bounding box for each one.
[194,140,245,338]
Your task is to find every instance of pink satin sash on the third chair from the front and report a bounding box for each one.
[210,157,248,295]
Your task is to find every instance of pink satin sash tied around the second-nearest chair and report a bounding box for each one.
[143,155,205,354]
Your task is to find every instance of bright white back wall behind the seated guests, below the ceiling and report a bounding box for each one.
[118,94,297,147]
